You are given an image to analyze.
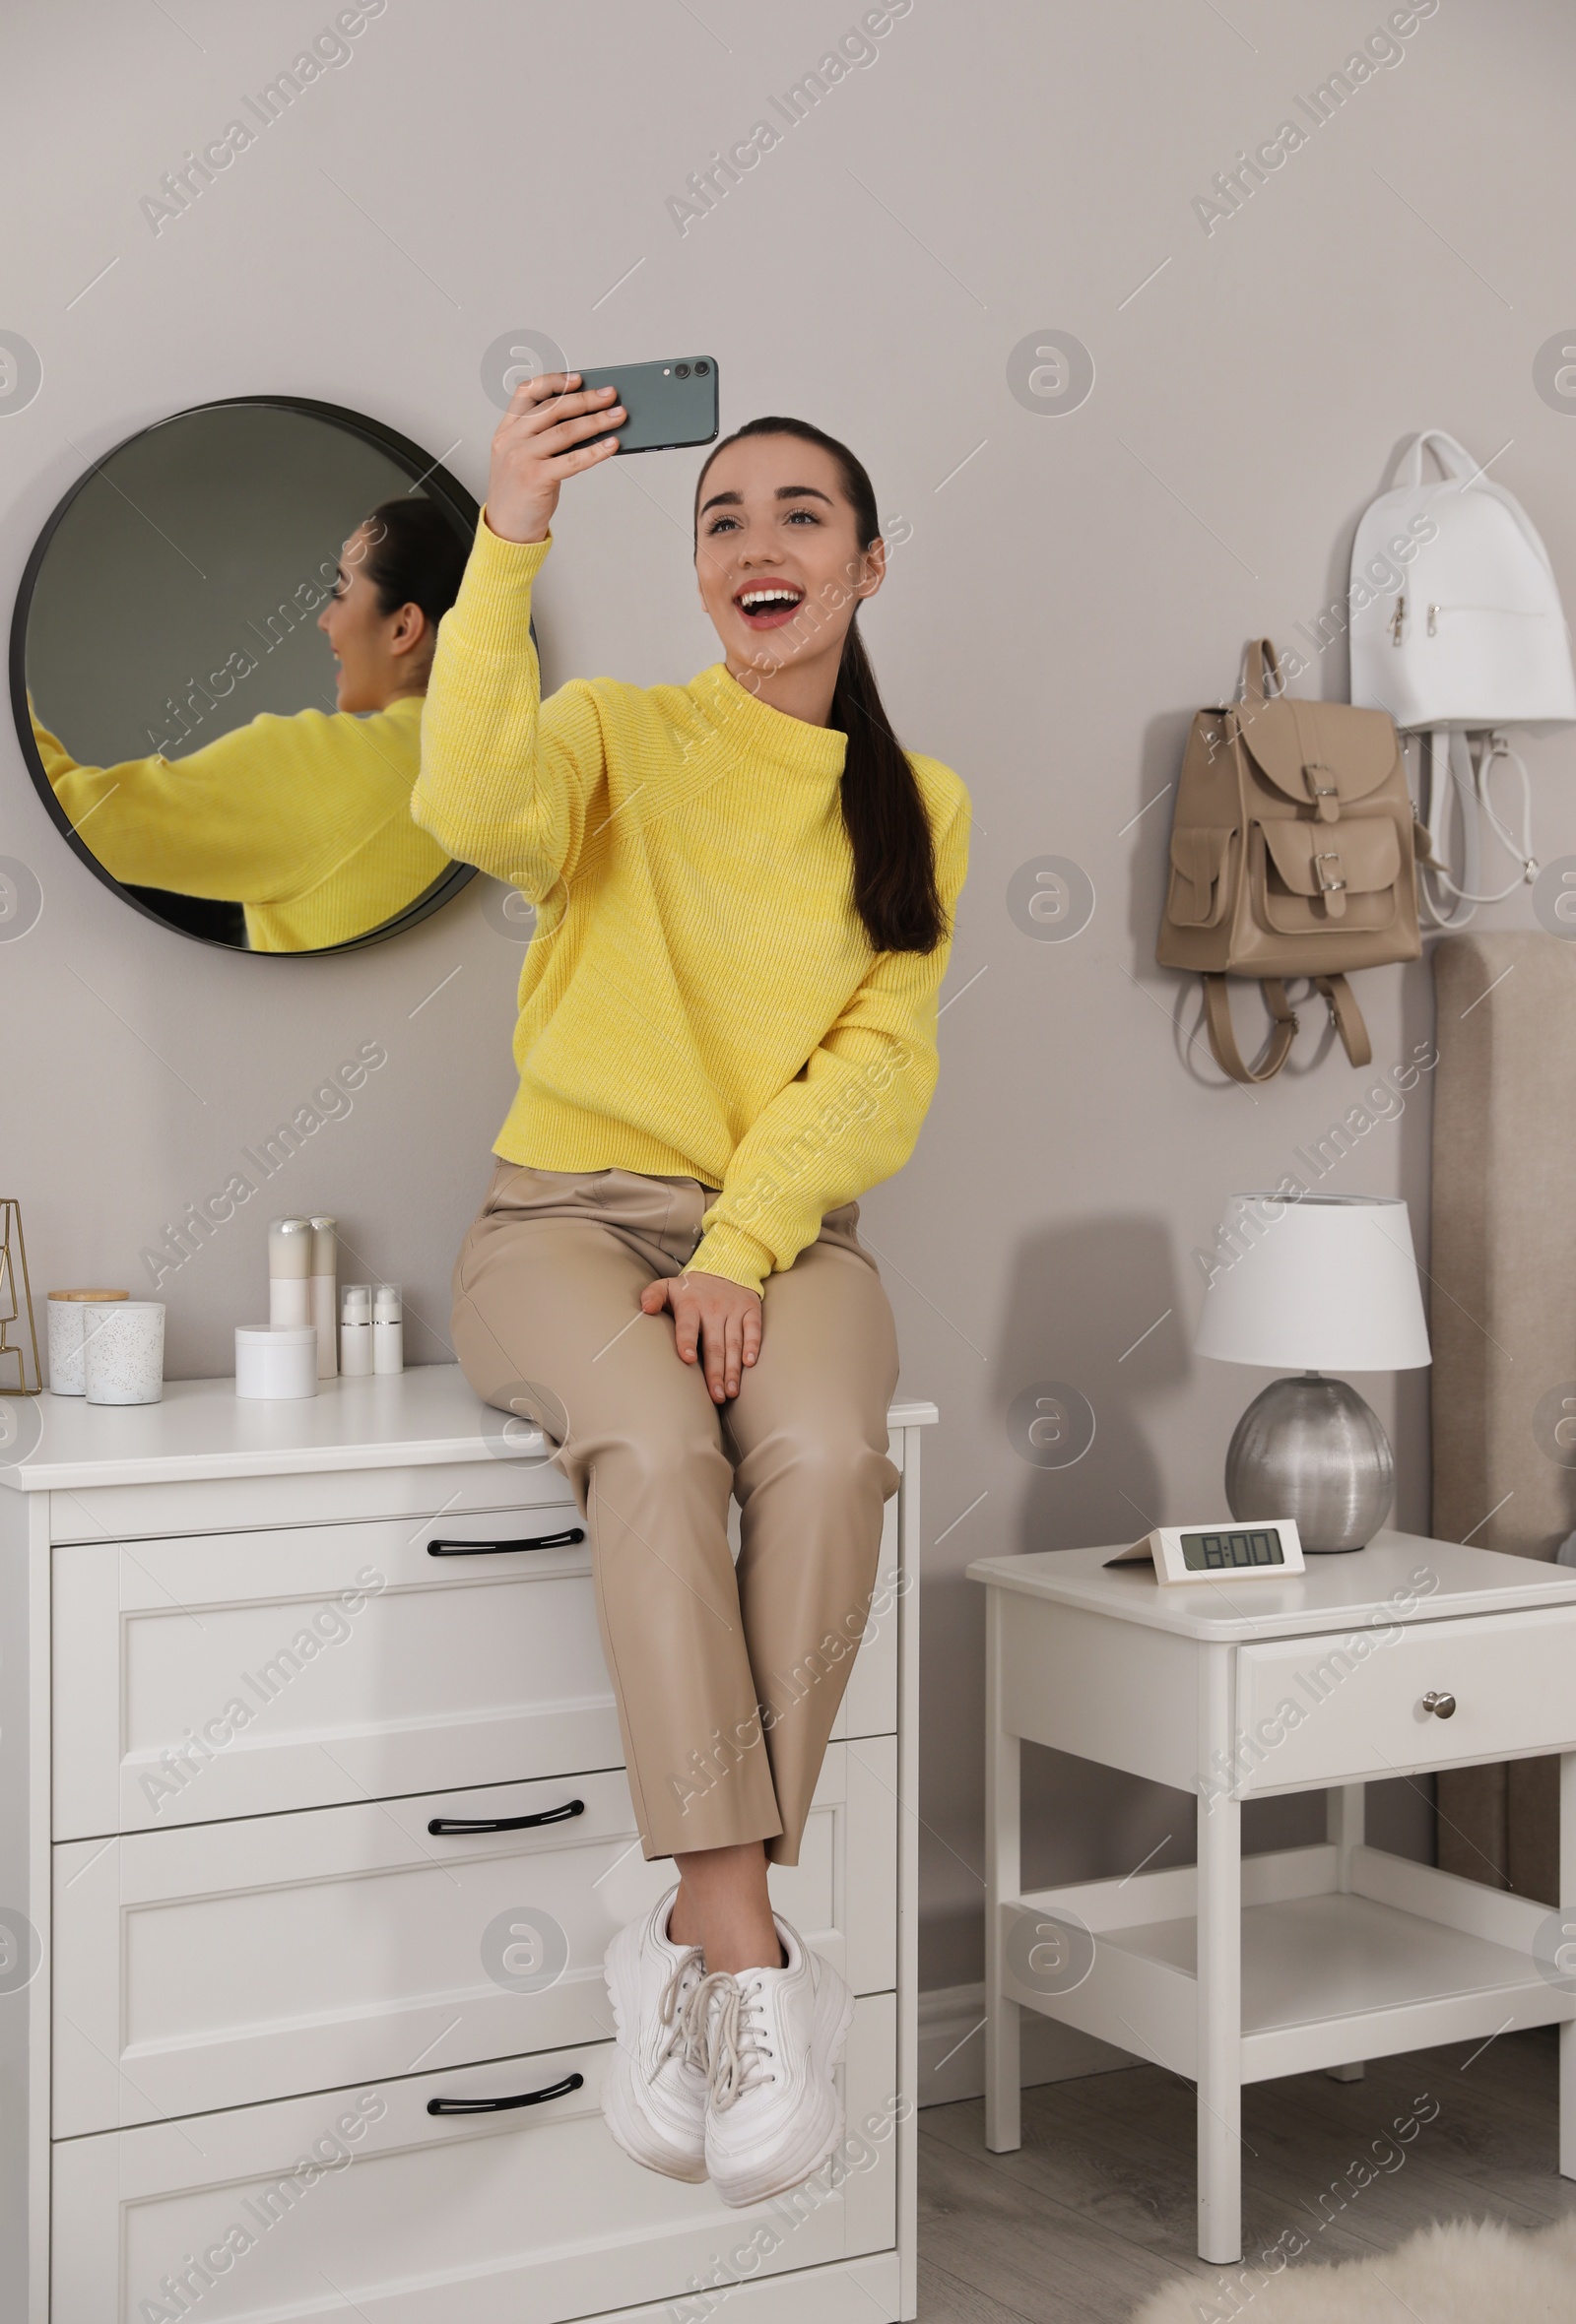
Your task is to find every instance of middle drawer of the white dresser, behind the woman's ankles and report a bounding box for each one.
[53,1736,897,2138]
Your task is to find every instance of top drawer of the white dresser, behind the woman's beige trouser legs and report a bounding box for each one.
[51,1497,897,1840]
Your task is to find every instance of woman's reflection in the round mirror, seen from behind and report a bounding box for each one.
[33,499,465,953]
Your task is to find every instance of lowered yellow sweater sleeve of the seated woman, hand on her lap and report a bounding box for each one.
[690,783,969,1292]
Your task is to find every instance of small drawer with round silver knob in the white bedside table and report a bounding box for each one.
[1236,1606,1576,1794]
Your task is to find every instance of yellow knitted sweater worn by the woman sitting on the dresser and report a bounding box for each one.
[412,518,969,1290]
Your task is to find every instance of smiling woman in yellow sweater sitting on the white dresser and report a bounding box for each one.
[412,372,969,2203]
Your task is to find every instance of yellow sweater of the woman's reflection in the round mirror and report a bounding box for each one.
[33,695,448,953]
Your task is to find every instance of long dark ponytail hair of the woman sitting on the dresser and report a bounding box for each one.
[695,419,949,953]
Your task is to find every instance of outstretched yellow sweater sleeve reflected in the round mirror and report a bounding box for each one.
[33,711,386,904]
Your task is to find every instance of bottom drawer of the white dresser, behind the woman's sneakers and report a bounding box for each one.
[49,1994,911,2324]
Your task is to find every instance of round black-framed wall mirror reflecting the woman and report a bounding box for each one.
[12,395,479,953]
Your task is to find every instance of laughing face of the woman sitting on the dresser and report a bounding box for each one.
[695,434,886,672]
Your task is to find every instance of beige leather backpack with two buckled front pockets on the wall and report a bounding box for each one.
[1155,637,1422,1080]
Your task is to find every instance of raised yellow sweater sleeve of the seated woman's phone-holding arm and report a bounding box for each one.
[412,511,607,904]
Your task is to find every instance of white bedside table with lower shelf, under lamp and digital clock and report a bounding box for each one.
[969,1531,1576,2264]
